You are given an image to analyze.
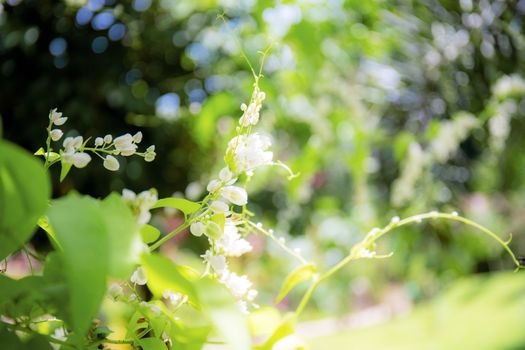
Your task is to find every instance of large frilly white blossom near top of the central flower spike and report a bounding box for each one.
[226,133,273,172]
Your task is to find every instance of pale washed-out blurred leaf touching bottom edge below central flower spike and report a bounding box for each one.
[195,278,252,350]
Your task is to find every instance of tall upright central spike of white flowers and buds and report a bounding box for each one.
[186,81,273,312]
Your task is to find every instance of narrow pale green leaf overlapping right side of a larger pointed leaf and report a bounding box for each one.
[100,193,142,278]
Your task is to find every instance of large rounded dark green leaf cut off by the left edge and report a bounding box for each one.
[0,141,51,259]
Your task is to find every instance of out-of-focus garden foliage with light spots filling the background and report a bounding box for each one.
[0,0,525,313]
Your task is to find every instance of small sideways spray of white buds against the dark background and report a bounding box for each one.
[42,108,156,171]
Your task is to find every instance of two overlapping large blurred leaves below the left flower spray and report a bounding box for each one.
[48,193,140,337]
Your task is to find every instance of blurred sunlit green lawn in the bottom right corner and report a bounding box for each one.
[309,273,525,350]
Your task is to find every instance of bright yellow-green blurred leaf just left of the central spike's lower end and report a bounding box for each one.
[142,254,198,305]
